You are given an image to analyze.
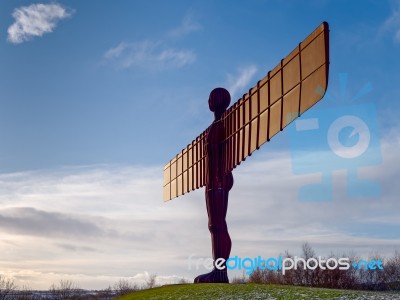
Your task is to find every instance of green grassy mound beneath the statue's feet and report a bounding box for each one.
[118,283,400,300]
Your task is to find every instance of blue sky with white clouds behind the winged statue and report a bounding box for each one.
[0,0,400,289]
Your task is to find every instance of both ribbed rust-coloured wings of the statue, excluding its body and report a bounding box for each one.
[163,22,329,201]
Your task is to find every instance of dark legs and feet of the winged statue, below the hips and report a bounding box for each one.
[194,189,232,283]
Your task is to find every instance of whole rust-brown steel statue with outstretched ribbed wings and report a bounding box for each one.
[164,22,329,283]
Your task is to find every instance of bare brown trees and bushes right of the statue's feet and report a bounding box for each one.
[245,243,400,291]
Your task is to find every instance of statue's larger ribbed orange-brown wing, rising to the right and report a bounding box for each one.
[223,23,329,172]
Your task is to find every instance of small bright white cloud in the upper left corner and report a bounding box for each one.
[7,3,71,44]
